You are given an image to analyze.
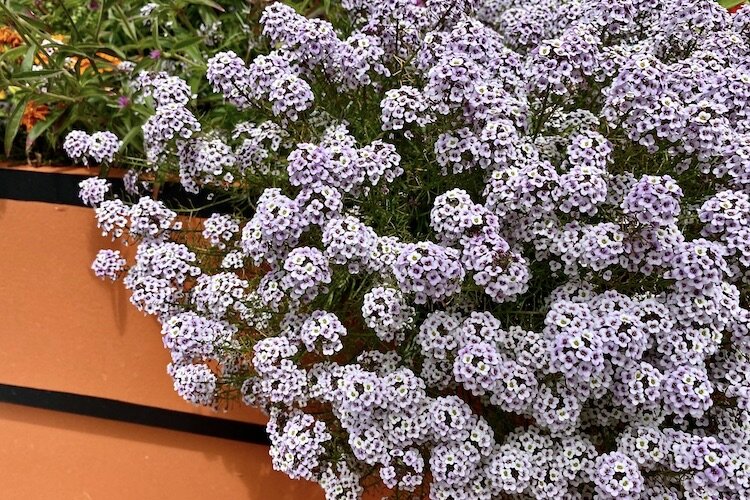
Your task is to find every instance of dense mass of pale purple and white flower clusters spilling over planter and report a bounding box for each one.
[81,0,750,500]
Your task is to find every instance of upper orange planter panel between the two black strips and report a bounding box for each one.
[0,200,264,422]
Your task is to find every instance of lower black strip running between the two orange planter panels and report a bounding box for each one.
[0,384,269,445]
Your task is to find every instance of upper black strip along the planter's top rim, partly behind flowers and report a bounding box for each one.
[0,168,232,217]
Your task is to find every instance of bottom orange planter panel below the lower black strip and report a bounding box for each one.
[0,404,322,500]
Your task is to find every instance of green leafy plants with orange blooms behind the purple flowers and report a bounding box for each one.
[0,0,292,163]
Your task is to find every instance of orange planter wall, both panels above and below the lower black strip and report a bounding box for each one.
[0,167,322,500]
